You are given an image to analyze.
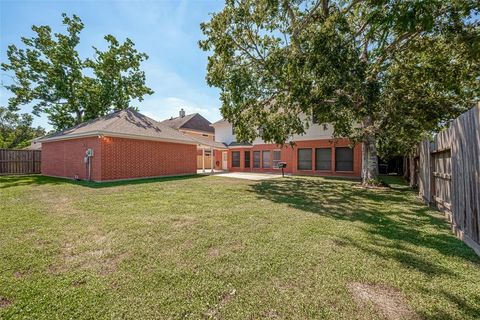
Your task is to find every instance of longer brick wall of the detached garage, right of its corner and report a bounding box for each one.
[102,137,197,180]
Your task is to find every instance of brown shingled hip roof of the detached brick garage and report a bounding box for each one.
[37,109,197,144]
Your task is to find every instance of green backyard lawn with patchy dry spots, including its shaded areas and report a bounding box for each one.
[0,176,480,319]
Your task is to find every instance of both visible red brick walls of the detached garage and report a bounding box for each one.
[42,137,197,181]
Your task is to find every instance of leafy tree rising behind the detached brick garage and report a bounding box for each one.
[2,14,153,130]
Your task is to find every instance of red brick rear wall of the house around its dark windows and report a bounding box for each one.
[228,139,362,177]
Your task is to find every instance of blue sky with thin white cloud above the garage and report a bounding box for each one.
[0,0,223,129]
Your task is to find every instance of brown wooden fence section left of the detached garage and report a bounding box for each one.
[0,149,42,175]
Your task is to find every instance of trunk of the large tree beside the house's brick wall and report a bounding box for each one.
[362,116,378,185]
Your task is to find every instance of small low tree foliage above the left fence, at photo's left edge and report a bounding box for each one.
[0,107,45,149]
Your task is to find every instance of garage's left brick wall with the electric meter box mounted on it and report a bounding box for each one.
[41,137,102,180]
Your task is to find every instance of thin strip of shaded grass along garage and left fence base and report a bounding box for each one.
[0,174,205,189]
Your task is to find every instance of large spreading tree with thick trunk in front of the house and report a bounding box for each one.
[200,0,479,183]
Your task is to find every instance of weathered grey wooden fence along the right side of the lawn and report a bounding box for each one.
[415,104,480,255]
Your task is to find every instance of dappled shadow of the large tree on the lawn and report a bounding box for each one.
[252,178,480,276]
